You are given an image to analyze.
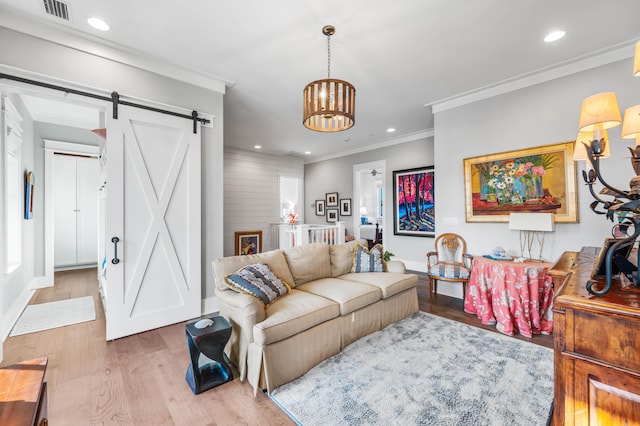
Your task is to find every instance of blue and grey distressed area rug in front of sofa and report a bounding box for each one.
[271,312,553,426]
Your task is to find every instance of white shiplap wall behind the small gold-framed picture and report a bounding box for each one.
[224,149,304,256]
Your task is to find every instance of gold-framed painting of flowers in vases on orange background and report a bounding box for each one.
[464,142,578,222]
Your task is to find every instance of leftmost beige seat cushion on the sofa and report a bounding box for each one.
[253,289,340,345]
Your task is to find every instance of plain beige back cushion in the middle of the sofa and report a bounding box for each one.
[283,243,331,285]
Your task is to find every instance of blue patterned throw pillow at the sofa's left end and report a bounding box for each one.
[226,263,291,305]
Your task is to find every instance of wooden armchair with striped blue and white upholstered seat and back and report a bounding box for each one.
[427,233,473,303]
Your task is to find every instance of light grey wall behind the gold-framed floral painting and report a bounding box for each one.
[435,60,640,290]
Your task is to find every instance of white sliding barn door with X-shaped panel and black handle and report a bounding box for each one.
[105,106,201,340]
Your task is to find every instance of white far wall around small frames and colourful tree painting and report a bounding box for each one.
[304,138,440,271]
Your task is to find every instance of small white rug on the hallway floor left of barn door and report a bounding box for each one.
[9,296,96,336]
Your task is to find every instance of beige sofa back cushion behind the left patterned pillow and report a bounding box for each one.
[211,250,295,290]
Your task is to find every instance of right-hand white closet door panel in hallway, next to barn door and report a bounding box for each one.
[76,157,98,264]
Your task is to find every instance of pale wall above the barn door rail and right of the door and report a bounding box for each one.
[0,27,224,313]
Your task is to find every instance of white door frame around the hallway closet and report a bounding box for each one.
[43,139,100,282]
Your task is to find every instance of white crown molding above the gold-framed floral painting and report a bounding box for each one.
[425,40,637,114]
